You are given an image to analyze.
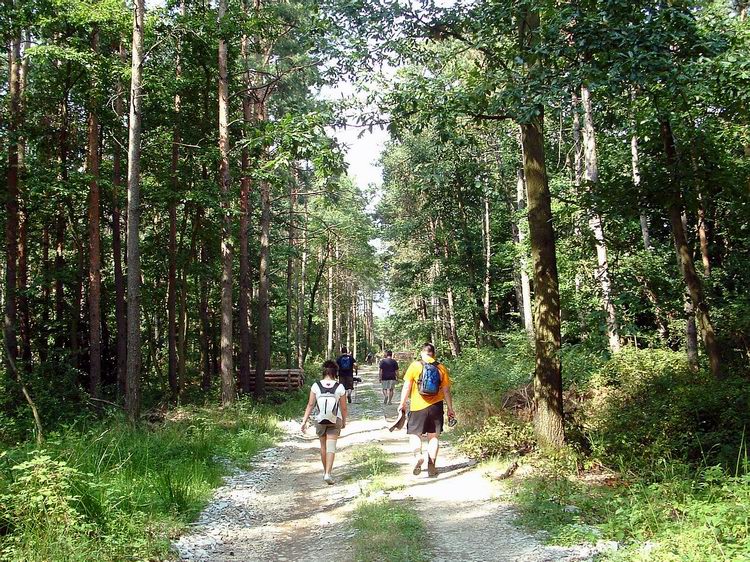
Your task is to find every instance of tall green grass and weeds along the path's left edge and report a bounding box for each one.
[0,394,290,562]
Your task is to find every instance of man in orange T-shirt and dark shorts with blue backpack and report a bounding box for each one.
[398,343,455,478]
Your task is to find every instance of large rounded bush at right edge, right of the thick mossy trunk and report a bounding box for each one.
[580,348,750,470]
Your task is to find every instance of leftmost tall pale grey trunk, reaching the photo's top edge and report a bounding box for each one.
[125,0,146,422]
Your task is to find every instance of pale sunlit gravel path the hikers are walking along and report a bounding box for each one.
[174,369,595,562]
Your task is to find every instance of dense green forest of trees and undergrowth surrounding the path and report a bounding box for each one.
[0,0,750,561]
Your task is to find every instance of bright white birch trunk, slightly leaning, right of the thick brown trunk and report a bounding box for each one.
[581,84,620,353]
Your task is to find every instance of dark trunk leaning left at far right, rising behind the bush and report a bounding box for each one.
[660,119,723,379]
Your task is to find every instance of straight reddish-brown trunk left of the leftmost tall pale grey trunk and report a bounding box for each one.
[86,31,102,398]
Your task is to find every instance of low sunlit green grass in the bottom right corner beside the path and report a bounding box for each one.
[506,460,750,562]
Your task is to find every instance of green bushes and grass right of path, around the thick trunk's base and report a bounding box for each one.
[451,336,750,562]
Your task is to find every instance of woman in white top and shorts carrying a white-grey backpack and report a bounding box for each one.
[300,360,347,484]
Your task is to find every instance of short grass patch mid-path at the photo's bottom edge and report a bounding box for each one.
[353,499,430,562]
